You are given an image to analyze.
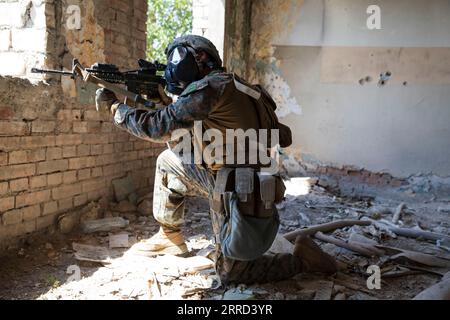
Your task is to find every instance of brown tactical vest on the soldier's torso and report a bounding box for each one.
[182,72,291,171]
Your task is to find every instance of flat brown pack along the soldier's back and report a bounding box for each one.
[233,74,292,148]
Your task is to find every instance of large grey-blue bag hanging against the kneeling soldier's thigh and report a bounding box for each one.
[219,192,280,261]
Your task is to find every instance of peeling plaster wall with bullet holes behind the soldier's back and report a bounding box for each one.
[225,0,450,177]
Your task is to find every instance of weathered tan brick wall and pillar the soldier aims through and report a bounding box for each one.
[0,0,165,249]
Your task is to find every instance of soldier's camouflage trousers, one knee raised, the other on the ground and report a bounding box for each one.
[153,150,302,284]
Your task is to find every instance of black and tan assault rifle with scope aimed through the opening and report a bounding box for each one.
[31,59,166,108]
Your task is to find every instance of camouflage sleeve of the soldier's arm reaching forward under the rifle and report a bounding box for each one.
[114,87,217,143]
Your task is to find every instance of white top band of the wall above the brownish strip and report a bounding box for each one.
[273,0,450,47]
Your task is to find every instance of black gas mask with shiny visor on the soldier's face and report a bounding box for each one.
[164,46,200,95]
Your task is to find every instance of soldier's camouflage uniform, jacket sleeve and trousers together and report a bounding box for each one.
[115,71,302,284]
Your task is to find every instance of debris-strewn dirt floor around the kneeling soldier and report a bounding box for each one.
[0,178,450,300]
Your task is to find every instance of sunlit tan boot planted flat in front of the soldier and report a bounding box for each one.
[131,227,188,256]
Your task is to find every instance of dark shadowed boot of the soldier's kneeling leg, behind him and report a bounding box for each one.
[294,236,338,275]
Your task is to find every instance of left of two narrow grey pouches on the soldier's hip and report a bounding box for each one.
[235,168,255,216]
